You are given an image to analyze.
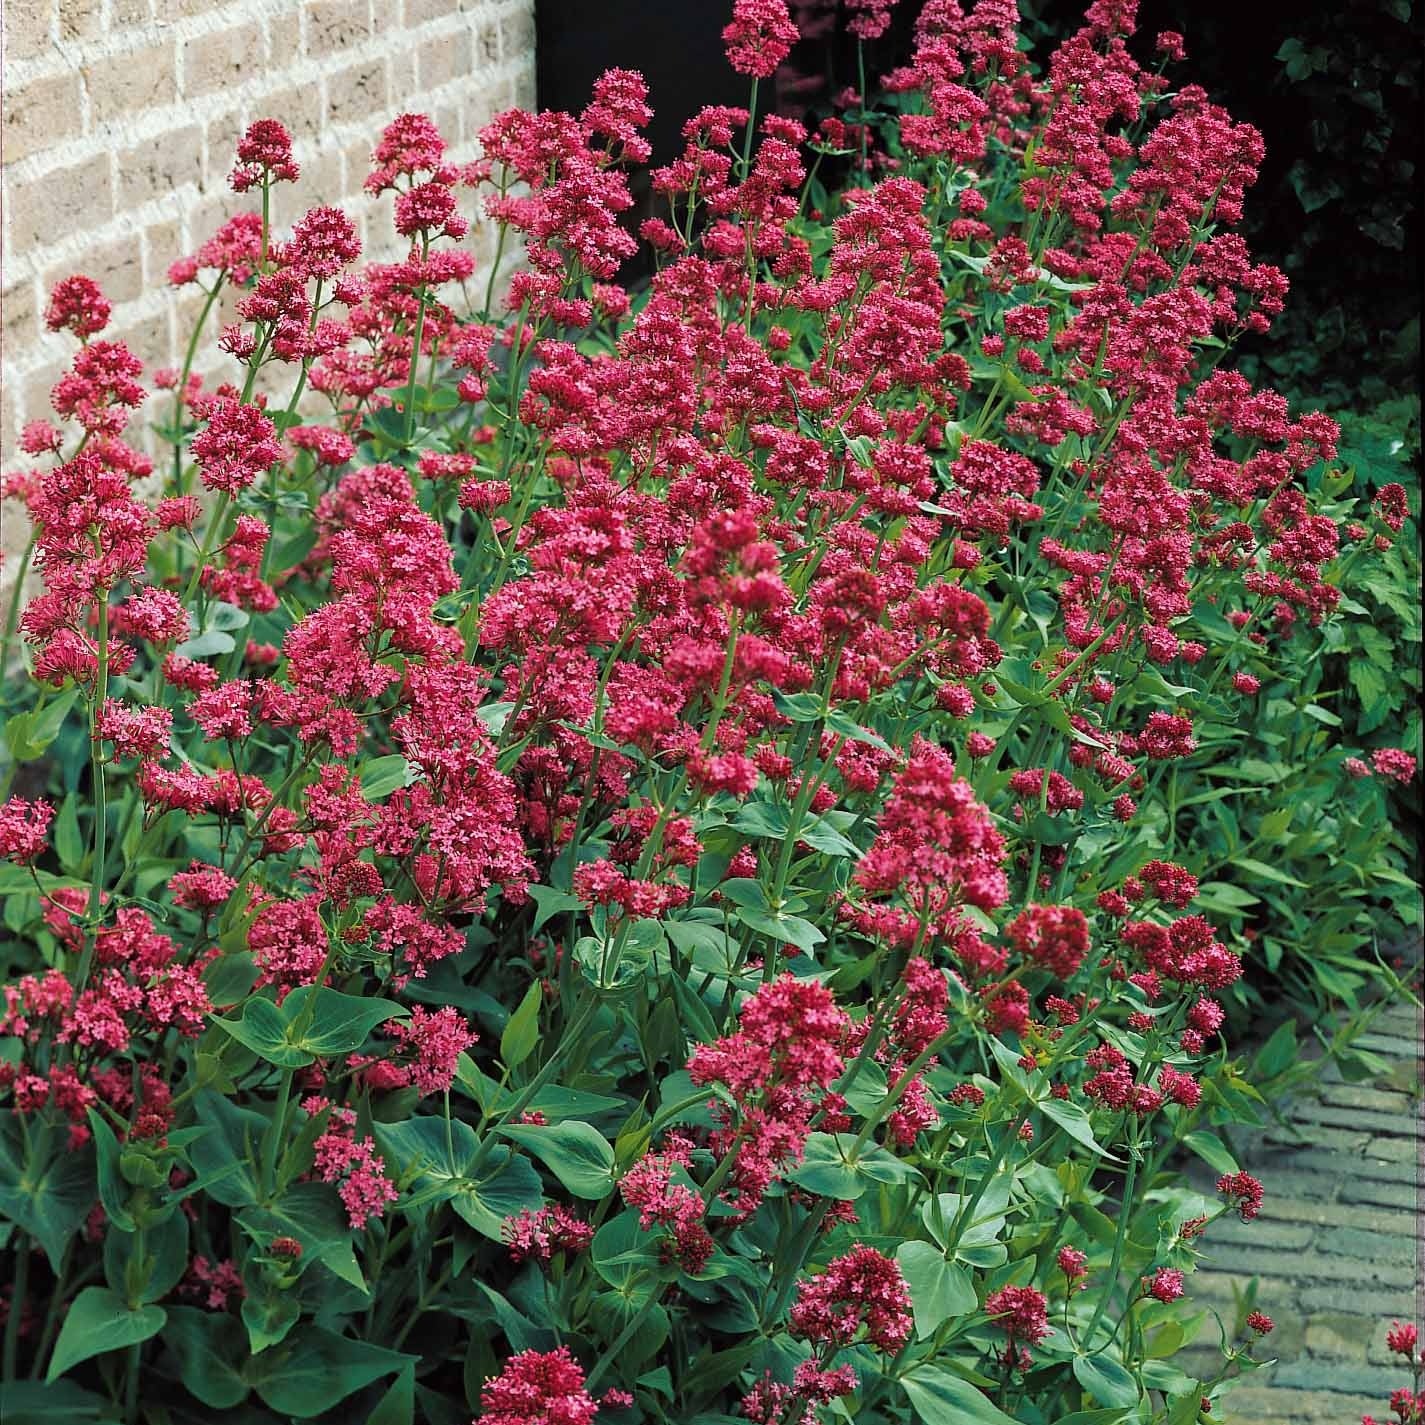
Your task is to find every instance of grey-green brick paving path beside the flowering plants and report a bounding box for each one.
[1193,1003,1425,1425]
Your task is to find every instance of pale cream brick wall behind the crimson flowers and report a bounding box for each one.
[0,0,534,587]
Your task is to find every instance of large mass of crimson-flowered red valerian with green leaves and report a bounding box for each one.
[0,0,1415,1425]
